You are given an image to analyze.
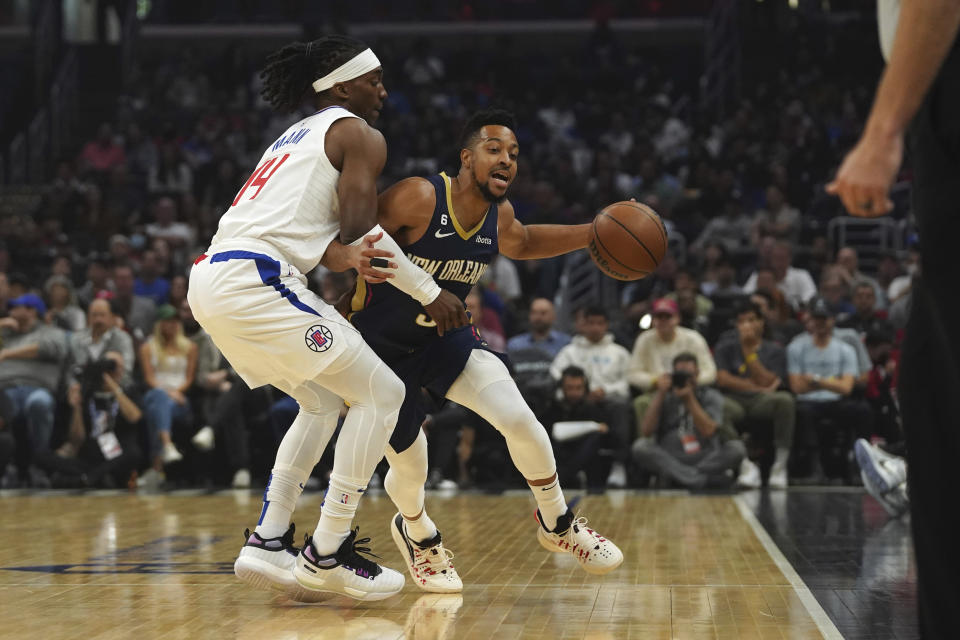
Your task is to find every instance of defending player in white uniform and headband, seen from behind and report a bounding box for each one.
[188,36,467,600]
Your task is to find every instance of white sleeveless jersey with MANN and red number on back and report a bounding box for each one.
[211,107,357,273]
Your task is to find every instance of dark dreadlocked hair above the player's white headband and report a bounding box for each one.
[260,35,367,111]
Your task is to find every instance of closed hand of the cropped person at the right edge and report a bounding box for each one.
[827,132,903,218]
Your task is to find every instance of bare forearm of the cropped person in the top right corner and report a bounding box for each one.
[866,0,960,137]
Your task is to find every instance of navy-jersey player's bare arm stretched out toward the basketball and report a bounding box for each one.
[497,202,590,260]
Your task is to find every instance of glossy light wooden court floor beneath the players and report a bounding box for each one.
[0,492,840,640]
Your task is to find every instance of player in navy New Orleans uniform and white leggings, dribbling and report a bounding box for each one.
[323,110,623,592]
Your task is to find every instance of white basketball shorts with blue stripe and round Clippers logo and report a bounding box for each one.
[187,243,368,389]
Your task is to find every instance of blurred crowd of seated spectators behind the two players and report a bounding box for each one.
[0,11,920,490]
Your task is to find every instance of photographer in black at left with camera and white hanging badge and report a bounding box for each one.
[37,351,143,488]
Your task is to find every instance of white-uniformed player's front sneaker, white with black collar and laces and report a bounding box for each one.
[293,529,404,600]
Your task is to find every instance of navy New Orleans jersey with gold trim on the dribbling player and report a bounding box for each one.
[348,173,498,358]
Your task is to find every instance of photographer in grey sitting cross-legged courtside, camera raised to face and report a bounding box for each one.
[633,353,746,489]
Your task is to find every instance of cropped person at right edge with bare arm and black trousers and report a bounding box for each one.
[827,0,960,639]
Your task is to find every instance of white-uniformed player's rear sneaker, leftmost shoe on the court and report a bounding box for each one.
[233,523,328,602]
